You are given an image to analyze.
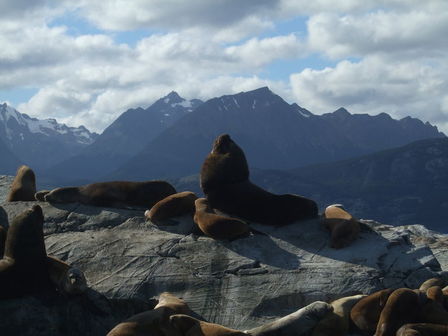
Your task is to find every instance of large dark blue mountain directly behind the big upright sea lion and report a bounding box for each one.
[109,87,444,179]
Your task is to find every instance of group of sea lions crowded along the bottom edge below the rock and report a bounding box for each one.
[107,278,448,336]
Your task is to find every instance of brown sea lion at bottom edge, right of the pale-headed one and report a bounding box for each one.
[170,314,247,336]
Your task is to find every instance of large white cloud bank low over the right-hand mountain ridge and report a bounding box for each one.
[290,56,448,131]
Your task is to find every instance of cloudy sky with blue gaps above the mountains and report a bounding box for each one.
[0,0,448,134]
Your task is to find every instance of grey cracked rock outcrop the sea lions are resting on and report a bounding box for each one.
[0,196,448,335]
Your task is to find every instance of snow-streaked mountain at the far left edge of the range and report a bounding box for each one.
[0,103,97,173]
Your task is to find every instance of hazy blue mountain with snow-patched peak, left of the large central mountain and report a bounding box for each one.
[46,92,202,183]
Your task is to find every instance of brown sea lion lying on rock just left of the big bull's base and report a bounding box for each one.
[145,191,198,223]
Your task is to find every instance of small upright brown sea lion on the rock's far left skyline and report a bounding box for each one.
[6,165,36,202]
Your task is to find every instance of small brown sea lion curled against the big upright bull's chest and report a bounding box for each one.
[194,198,250,239]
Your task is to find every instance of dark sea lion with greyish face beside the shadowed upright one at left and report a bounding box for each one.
[47,256,87,295]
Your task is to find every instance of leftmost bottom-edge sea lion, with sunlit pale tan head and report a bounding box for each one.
[107,292,192,336]
